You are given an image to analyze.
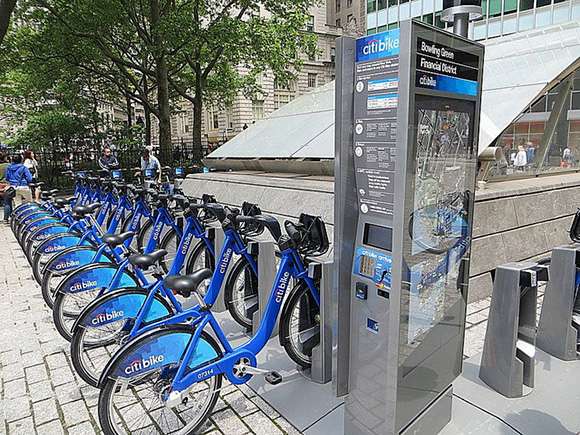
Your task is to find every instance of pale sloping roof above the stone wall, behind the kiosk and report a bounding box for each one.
[208,22,580,159]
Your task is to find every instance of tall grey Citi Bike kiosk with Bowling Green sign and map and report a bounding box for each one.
[334,21,484,434]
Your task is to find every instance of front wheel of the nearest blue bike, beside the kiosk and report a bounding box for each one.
[279,281,320,368]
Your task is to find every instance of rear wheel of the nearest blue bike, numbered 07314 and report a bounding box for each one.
[99,325,223,435]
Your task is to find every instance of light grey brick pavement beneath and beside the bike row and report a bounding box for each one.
[0,224,516,435]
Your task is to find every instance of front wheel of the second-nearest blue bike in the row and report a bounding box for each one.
[224,256,259,329]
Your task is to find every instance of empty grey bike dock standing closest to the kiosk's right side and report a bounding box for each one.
[479,263,548,398]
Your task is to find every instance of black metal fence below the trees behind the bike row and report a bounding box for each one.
[35,144,203,190]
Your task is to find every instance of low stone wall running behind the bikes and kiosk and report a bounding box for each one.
[183,172,580,302]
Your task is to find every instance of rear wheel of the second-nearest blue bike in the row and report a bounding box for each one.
[71,288,175,387]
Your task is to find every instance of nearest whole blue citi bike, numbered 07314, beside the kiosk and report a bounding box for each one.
[99,215,328,435]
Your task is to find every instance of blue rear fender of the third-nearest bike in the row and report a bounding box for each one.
[58,263,139,293]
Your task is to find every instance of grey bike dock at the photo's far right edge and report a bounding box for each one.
[537,244,580,361]
